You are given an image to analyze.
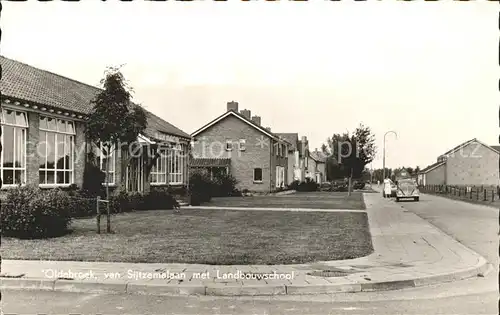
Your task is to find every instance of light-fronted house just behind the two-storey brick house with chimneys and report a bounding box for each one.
[276,133,309,185]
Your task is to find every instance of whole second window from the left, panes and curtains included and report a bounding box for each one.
[38,116,75,185]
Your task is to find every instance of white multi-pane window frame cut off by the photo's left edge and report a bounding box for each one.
[0,107,29,188]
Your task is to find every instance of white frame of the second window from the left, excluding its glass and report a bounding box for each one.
[38,115,76,188]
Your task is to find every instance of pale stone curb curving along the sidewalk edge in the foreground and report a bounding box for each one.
[0,257,492,296]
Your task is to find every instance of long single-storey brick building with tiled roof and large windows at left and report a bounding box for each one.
[0,57,191,196]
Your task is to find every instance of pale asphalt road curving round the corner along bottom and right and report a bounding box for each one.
[2,195,499,315]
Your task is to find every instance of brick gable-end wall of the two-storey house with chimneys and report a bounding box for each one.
[193,116,276,192]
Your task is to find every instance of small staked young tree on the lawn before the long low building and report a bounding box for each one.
[86,67,147,232]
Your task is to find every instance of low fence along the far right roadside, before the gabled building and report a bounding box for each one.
[420,185,500,203]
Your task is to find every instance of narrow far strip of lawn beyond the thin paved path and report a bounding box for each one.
[203,192,365,210]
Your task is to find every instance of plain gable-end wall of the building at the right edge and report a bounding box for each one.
[446,142,499,186]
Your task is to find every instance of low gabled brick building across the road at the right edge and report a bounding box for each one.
[417,139,500,186]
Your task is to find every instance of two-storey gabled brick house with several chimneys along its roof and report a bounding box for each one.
[191,101,292,192]
